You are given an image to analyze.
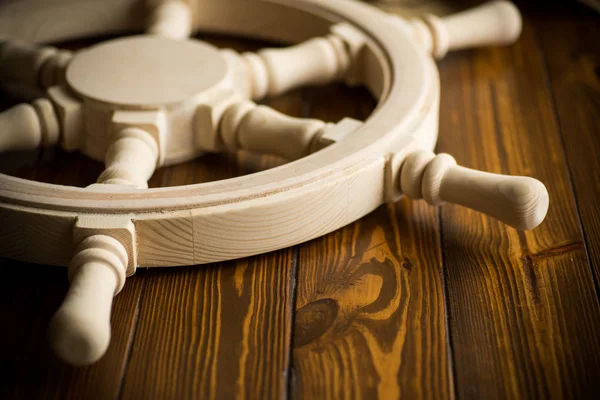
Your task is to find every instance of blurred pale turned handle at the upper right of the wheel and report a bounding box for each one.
[412,1,522,59]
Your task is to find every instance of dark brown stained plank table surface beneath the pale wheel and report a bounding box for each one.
[0,1,600,399]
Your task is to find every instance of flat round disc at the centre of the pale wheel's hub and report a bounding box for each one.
[66,36,227,108]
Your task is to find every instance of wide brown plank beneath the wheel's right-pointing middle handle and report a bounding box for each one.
[438,14,600,399]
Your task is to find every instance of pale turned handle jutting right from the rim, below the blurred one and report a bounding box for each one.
[400,150,549,229]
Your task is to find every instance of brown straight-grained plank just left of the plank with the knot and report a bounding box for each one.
[122,250,293,399]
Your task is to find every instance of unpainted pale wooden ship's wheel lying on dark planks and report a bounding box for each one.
[0,0,548,365]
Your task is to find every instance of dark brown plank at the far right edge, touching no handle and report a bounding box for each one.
[534,2,600,290]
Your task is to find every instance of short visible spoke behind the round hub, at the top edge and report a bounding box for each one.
[146,0,192,39]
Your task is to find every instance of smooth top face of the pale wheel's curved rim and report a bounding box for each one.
[0,0,437,214]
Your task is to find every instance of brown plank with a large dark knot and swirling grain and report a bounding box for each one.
[292,86,451,399]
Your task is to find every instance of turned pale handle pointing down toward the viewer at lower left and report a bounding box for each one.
[49,235,128,365]
